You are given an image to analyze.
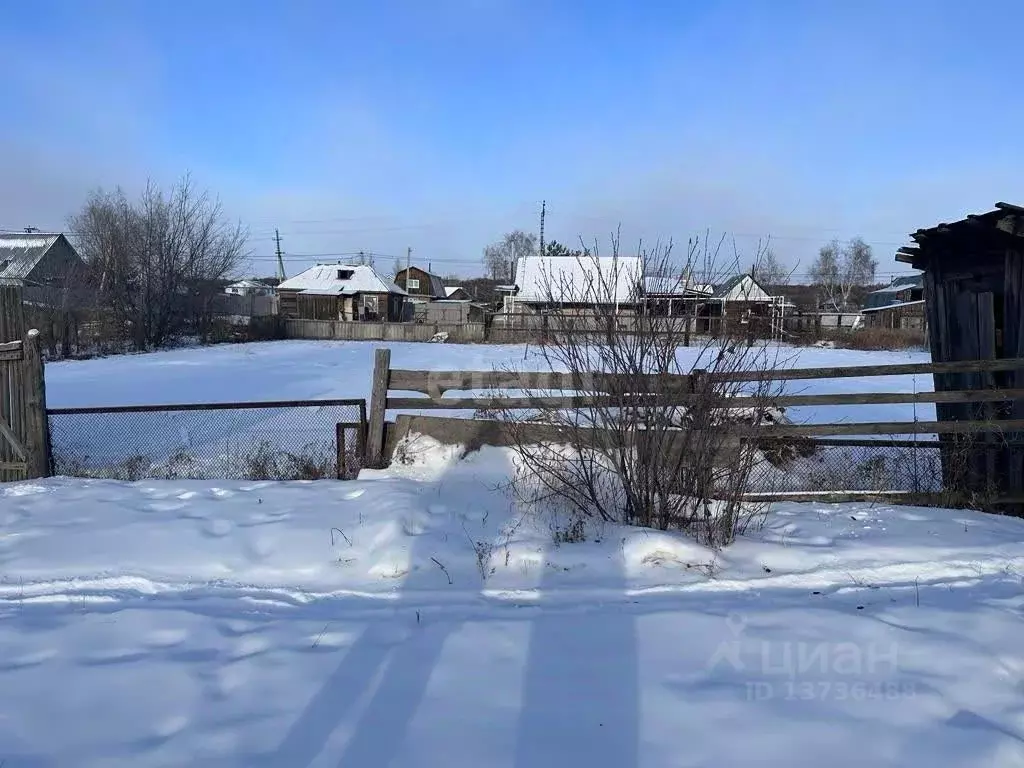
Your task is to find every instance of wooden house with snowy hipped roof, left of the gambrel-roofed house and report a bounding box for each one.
[278,264,406,322]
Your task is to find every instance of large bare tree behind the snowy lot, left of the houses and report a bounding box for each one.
[71,176,247,349]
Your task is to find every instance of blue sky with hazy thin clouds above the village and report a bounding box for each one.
[0,0,1024,275]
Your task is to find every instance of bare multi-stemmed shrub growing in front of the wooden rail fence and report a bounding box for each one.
[495,238,779,546]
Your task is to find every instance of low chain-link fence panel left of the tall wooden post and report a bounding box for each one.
[47,399,367,480]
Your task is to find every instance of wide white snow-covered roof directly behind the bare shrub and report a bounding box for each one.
[515,256,643,304]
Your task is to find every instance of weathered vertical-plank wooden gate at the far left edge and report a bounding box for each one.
[0,330,50,482]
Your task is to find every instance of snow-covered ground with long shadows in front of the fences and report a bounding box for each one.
[0,438,1024,768]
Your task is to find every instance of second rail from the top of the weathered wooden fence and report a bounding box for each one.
[387,389,1024,411]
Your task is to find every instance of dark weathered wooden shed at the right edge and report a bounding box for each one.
[896,203,1024,507]
